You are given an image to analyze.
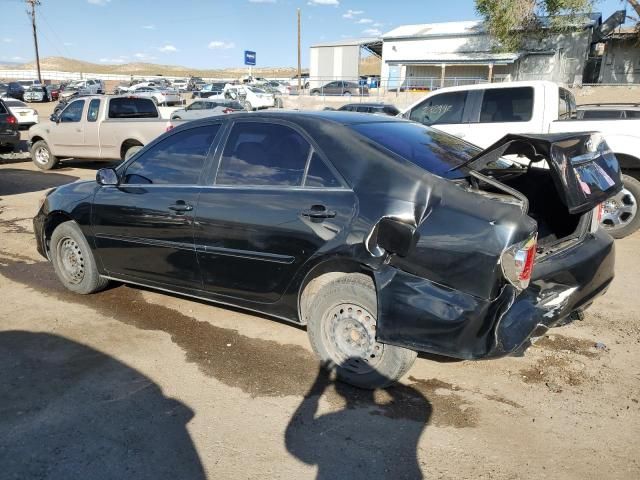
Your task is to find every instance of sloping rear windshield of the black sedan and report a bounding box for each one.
[349,122,480,178]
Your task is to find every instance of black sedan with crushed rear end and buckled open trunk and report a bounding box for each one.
[34,112,621,388]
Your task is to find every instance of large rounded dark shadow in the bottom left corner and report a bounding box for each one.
[0,331,205,480]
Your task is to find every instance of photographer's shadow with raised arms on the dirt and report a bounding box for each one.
[285,368,431,480]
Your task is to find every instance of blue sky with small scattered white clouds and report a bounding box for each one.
[0,0,623,68]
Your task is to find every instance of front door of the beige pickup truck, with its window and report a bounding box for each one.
[49,100,87,158]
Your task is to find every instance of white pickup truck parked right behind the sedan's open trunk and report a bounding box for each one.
[403,81,640,238]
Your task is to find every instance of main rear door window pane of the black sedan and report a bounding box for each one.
[216,122,311,186]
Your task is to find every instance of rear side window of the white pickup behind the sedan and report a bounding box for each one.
[479,87,533,123]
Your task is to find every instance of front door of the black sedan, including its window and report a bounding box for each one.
[92,124,220,288]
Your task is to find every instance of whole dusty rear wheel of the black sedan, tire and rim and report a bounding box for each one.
[307,273,417,389]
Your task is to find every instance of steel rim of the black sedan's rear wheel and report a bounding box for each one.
[322,303,384,374]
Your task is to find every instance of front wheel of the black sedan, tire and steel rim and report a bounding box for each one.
[49,221,109,295]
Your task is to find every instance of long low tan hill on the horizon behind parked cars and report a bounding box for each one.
[12,57,306,78]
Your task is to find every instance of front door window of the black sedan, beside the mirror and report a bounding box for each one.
[123,124,220,185]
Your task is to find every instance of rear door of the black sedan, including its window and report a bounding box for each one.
[195,121,355,303]
